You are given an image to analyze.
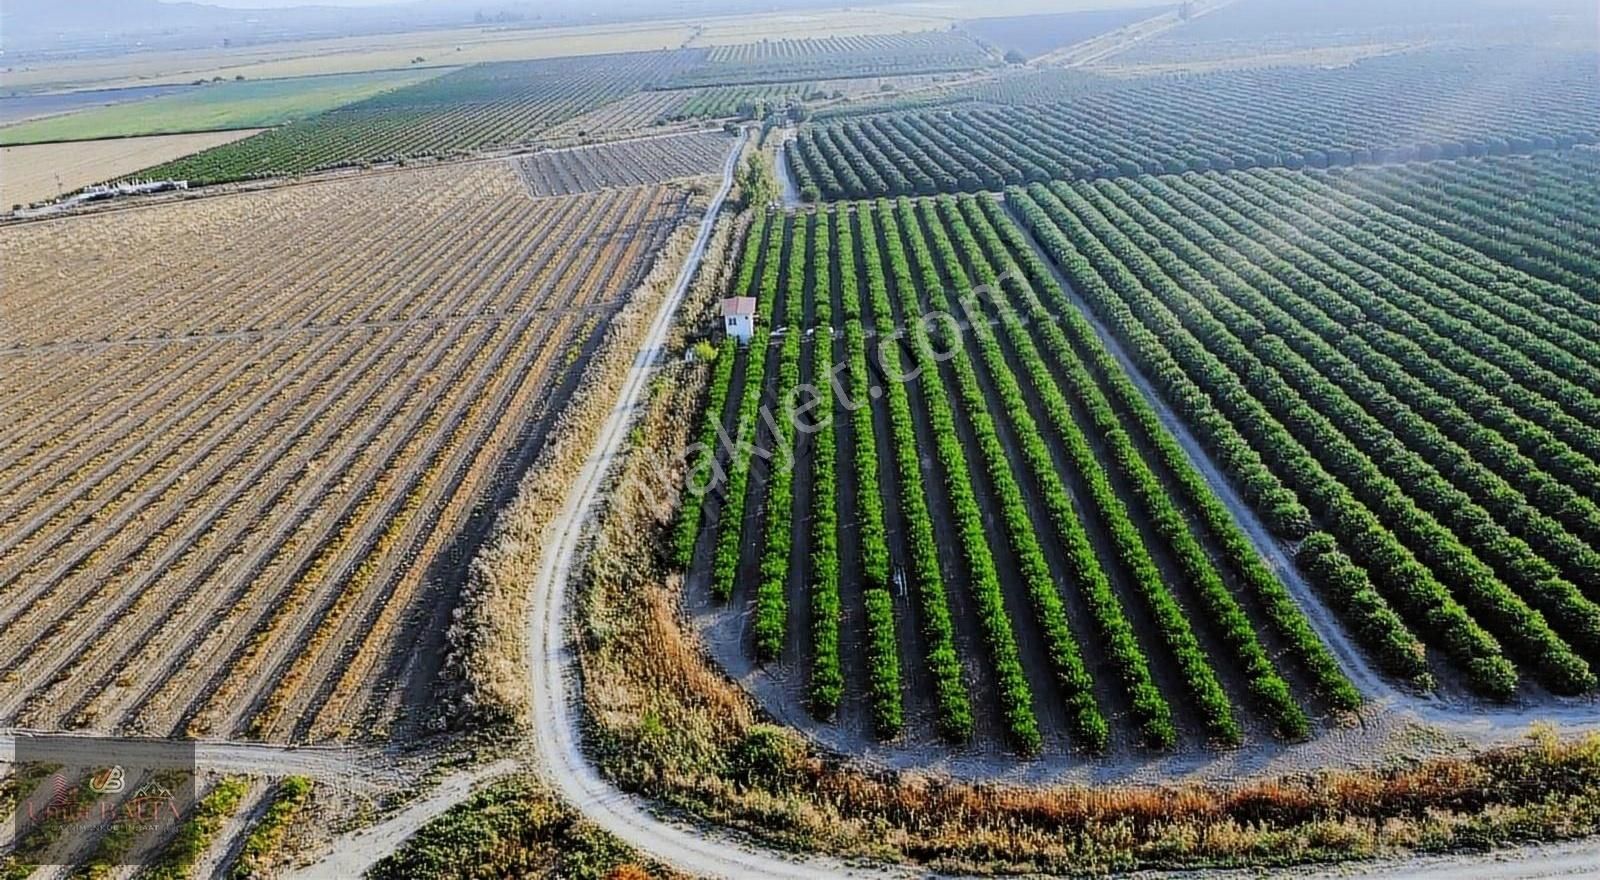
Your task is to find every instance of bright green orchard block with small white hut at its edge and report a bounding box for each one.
[675,197,1360,752]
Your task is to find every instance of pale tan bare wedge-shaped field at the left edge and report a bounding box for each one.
[0,128,261,208]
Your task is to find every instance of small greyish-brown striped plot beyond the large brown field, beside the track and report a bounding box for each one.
[517,131,733,195]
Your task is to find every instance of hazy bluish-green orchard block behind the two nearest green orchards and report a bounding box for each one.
[795,51,1600,198]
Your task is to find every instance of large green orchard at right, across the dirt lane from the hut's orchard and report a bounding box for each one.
[1006,149,1600,699]
